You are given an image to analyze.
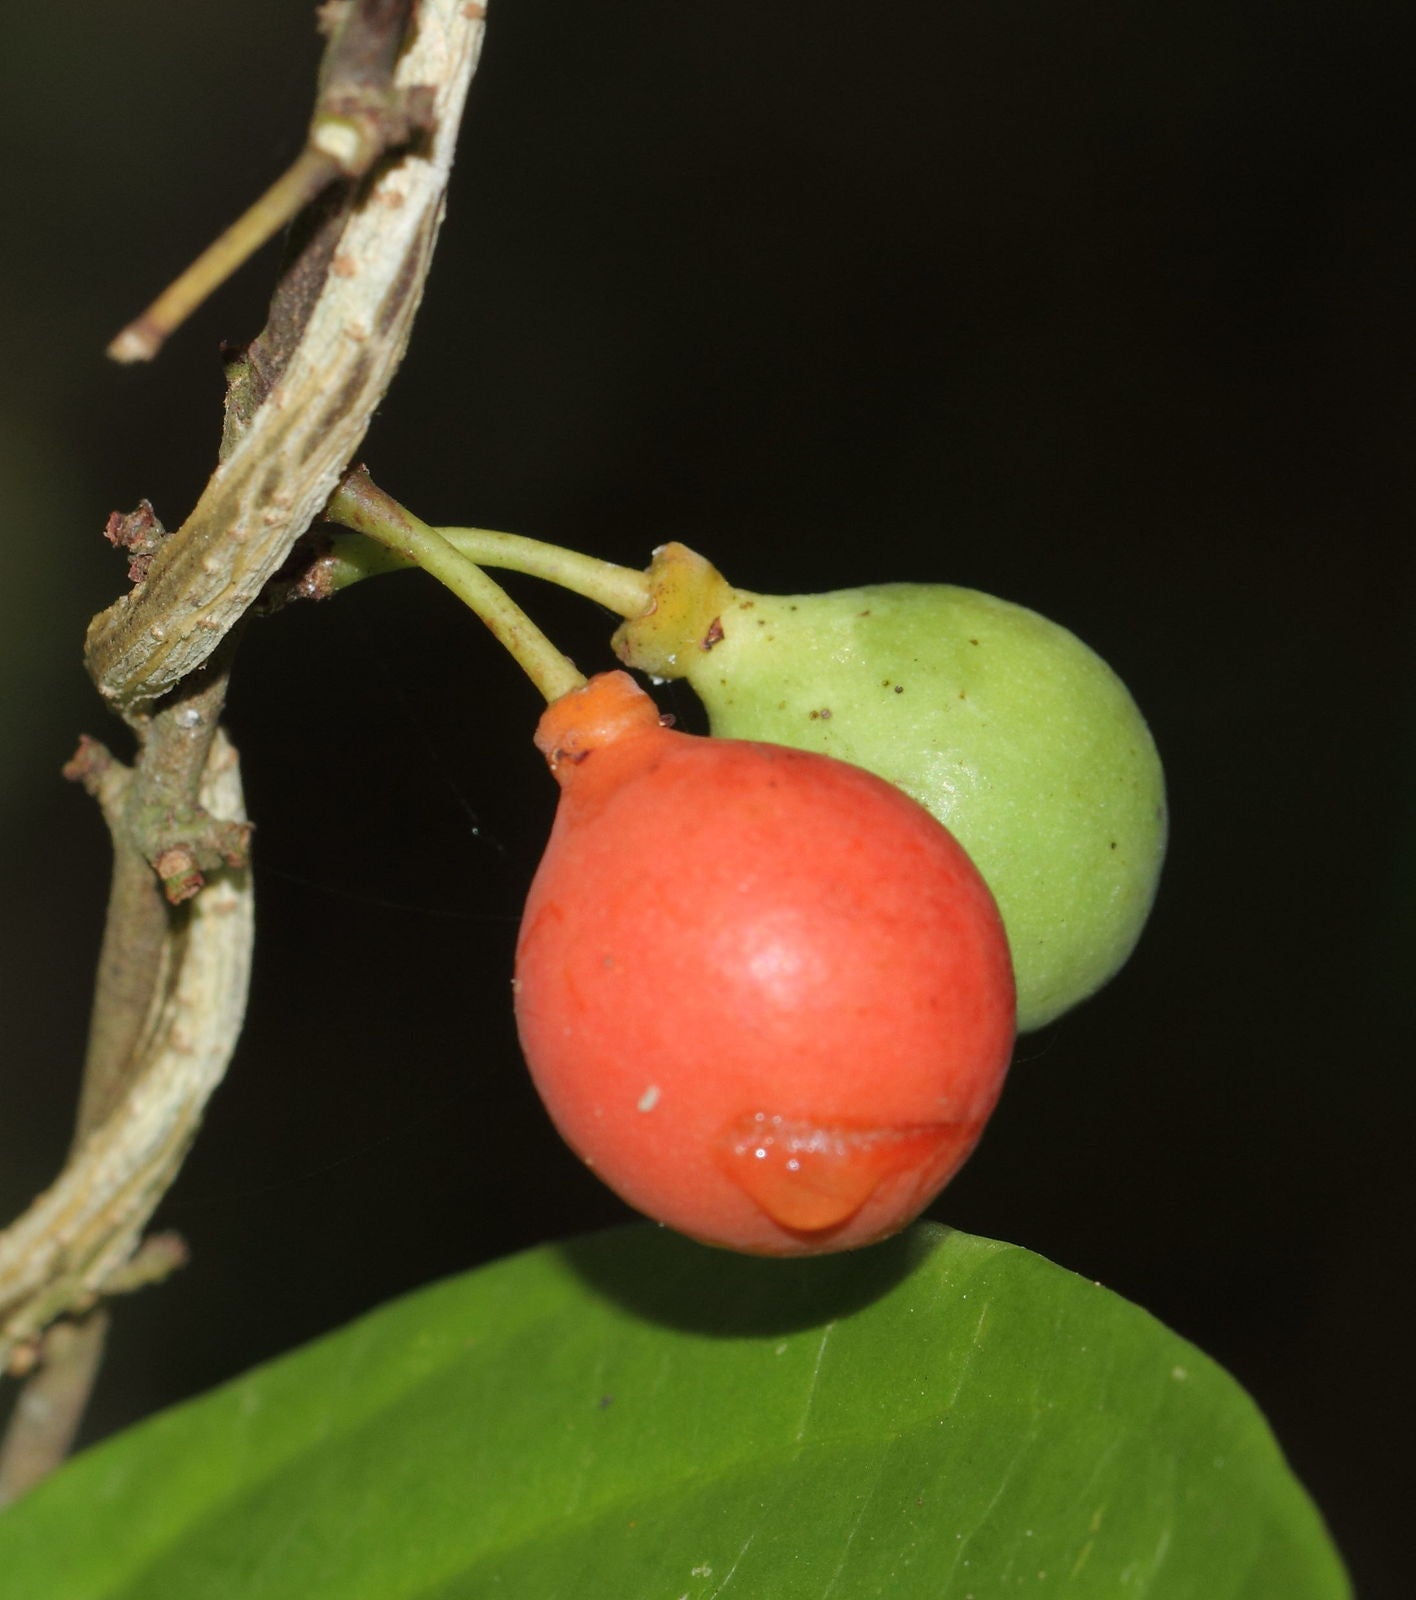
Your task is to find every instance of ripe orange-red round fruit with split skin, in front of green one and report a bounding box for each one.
[517,672,1014,1256]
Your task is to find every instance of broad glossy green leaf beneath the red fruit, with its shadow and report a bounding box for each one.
[0,1227,1349,1600]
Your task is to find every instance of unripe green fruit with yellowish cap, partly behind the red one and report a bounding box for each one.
[614,544,1166,1030]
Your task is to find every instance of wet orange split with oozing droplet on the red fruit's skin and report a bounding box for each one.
[715,1112,968,1234]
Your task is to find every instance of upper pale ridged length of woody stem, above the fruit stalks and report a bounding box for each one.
[86,0,483,709]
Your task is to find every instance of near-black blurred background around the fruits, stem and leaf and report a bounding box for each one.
[0,0,1416,1597]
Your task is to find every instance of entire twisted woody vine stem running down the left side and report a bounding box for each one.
[0,0,483,1482]
